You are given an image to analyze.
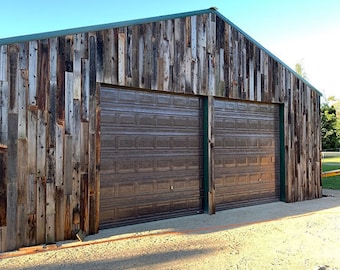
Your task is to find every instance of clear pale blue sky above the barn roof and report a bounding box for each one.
[0,0,340,99]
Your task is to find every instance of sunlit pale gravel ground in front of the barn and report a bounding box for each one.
[0,190,340,270]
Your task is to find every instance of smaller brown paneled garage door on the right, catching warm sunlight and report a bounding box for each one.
[214,99,280,209]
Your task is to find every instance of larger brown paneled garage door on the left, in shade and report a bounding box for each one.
[100,88,203,228]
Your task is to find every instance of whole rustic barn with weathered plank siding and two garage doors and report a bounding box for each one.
[0,9,322,252]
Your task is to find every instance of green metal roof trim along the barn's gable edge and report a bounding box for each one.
[0,8,322,96]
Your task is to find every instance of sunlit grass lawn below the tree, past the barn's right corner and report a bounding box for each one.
[322,157,340,190]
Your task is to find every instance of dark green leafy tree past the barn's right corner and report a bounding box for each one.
[321,103,340,151]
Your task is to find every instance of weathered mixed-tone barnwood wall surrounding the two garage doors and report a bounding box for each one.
[0,10,321,252]
